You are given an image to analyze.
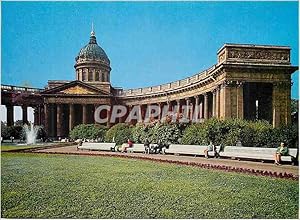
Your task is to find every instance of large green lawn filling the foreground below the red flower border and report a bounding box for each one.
[1,153,298,218]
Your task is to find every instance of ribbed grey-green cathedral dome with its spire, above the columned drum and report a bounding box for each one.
[75,31,110,65]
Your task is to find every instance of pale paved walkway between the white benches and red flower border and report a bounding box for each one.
[33,146,299,177]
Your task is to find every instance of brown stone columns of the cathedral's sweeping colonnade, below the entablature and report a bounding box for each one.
[2,81,291,137]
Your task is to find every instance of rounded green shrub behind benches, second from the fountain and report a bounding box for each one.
[105,123,132,145]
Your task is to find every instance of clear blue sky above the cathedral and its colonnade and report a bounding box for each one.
[1,2,299,122]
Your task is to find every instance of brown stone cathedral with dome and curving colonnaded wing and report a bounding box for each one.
[1,28,298,137]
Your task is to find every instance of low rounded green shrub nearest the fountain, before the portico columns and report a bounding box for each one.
[69,124,107,139]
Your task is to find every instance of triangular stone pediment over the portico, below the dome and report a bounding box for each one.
[43,81,109,95]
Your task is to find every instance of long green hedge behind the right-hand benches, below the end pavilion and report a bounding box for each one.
[182,118,298,147]
